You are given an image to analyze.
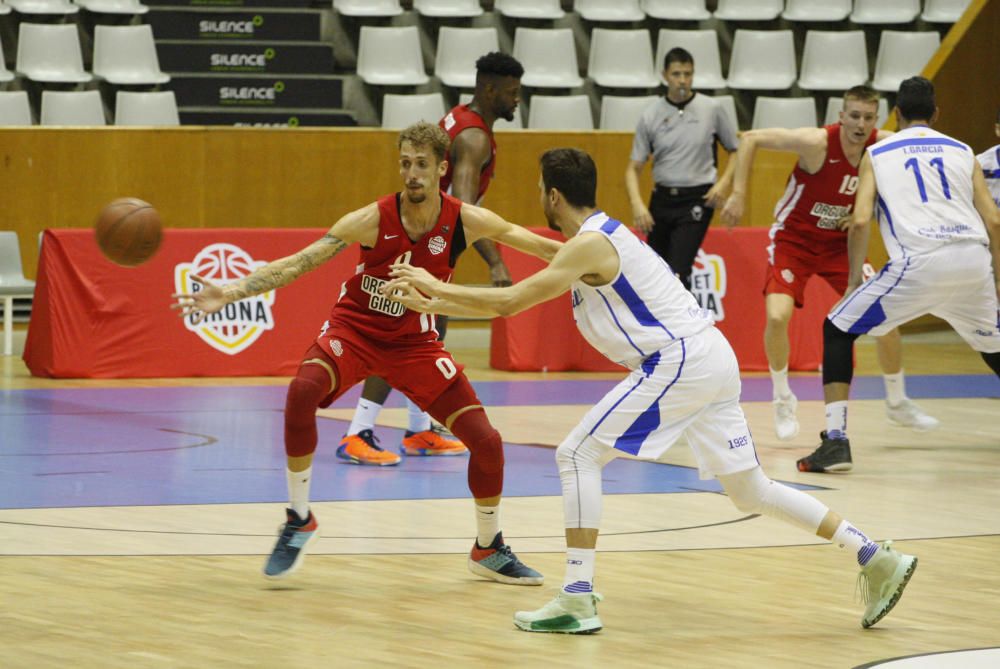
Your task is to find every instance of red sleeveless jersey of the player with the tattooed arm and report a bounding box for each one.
[330,193,465,341]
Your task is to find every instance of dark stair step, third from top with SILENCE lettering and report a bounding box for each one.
[169,72,344,109]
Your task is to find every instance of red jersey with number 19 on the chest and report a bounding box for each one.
[771,123,876,251]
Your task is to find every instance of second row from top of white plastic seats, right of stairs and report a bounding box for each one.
[366,26,941,91]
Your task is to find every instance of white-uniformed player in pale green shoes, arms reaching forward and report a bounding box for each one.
[384,149,917,634]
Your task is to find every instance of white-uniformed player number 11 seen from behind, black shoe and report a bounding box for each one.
[798,77,1000,472]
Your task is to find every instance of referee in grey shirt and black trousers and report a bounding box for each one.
[625,47,739,290]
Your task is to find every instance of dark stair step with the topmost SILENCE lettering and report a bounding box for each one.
[146,7,322,42]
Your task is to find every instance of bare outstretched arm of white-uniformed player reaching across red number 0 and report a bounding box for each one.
[383,234,618,316]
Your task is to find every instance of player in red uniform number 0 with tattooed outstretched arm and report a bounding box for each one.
[173,123,561,585]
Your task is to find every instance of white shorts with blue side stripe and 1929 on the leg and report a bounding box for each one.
[567,327,760,479]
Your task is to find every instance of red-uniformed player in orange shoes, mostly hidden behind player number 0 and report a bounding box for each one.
[337,51,524,466]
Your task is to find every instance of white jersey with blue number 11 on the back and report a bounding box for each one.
[868,126,989,260]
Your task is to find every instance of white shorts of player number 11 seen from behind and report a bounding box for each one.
[830,242,1000,353]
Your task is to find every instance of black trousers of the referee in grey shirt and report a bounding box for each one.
[647,185,715,290]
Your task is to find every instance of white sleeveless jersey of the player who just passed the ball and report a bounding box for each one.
[572,212,714,369]
